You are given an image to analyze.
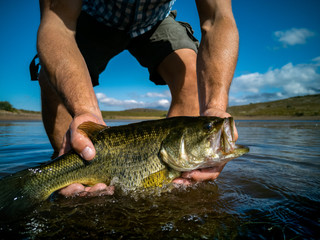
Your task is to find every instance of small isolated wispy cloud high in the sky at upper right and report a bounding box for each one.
[274,28,315,46]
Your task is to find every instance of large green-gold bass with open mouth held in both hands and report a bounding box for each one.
[0,116,249,218]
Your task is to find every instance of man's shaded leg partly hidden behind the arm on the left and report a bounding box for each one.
[39,70,72,157]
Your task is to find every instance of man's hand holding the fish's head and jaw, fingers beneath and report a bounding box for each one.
[173,108,238,185]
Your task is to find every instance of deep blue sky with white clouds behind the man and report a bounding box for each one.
[0,0,320,110]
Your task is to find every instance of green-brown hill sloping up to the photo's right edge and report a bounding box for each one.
[228,94,320,117]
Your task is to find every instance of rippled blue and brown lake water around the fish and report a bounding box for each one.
[0,121,320,239]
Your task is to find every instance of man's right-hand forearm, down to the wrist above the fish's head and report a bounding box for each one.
[196,0,239,117]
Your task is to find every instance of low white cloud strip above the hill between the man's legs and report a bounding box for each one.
[96,93,170,109]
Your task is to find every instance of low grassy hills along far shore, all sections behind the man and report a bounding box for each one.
[0,94,320,120]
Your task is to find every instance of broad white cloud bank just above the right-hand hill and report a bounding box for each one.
[230,57,320,105]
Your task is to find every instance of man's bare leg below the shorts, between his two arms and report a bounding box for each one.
[158,48,199,117]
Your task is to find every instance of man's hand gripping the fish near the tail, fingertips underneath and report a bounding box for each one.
[59,113,114,197]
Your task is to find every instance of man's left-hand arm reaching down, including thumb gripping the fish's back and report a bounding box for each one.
[37,0,104,160]
